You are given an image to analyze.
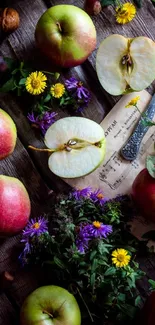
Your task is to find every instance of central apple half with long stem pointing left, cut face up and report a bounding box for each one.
[30,116,106,178]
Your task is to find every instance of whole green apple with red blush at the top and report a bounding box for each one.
[35,4,96,68]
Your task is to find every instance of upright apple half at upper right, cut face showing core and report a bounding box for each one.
[96,34,155,95]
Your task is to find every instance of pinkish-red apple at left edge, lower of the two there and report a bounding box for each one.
[0,175,31,235]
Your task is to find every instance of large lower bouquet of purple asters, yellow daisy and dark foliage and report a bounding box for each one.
[19,187,143,324]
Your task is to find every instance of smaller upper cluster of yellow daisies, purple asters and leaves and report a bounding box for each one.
[0,56,91,135]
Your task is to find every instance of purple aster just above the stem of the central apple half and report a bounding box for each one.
[27,112,57,135]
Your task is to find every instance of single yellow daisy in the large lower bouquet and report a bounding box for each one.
[111,248,131,267]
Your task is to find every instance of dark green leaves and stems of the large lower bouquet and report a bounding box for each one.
[21,196,144,321]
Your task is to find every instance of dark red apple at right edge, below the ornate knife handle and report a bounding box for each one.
[132,168,155,221]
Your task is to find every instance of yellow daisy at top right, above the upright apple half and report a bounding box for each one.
[116,2,136,24]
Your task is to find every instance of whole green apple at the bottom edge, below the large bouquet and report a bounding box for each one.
[20,285,81,325]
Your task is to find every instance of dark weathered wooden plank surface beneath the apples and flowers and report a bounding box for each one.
[0,0,155,325]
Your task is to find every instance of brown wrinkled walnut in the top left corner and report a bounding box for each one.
[0,8,20,33]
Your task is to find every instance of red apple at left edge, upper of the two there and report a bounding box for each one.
[0,109,17,160]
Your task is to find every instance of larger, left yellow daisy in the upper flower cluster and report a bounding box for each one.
[25,71,47,95]
